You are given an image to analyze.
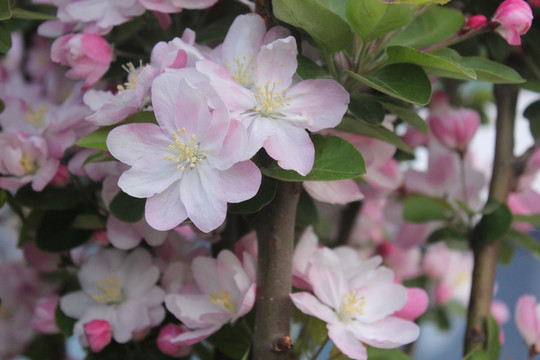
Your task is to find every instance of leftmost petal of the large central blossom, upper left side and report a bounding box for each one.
[107,124,173,166]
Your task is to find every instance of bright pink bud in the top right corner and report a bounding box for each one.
[491,0,533,45]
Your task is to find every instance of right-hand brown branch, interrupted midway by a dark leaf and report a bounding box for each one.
[464,85,519,354]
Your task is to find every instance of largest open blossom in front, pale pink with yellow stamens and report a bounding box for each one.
[107,73,261,232]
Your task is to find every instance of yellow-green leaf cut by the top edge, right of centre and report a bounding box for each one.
[345,0,418,41]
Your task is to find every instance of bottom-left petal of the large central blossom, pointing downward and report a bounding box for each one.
[144,182,188,231]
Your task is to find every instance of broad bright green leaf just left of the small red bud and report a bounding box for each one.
[390,6,465,48]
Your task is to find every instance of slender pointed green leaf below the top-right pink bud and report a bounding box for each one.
[430,48,525,84]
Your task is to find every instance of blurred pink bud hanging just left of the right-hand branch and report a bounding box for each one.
[428,108,480,152]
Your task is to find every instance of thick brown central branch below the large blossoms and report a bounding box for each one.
[252,182,302,360]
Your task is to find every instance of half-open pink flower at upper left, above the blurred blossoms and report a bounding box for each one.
[51,34,112,88]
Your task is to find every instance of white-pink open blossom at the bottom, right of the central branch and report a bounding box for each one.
[291,248,419,360]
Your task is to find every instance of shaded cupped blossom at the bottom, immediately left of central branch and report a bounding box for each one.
[165,250,256,345]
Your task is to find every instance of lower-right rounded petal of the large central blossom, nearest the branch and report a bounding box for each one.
[219,161,261,203]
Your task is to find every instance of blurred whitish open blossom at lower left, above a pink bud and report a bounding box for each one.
[60,248,165,343]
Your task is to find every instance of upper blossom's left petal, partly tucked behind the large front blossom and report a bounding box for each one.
[196,60,257,112]
